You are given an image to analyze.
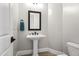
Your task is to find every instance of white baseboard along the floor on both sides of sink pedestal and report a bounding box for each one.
[16,48,63,56]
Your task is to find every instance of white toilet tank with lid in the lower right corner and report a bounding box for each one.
[67,42,79,56]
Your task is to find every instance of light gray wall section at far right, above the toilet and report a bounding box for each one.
[63,3,79,53]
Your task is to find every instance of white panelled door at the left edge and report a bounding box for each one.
[0,3,12,55]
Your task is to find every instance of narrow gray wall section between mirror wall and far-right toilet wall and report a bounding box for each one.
[48,3,62,51]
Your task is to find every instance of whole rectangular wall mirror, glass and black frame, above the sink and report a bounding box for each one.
[28,11,41,30]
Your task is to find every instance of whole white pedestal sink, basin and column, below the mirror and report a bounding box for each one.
[27,34,46,56]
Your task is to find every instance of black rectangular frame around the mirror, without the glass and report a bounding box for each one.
[28,10,41,31]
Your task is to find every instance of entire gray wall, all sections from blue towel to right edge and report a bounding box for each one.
[15,3,79,53]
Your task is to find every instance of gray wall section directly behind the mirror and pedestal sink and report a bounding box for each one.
[18,3,48,51]
